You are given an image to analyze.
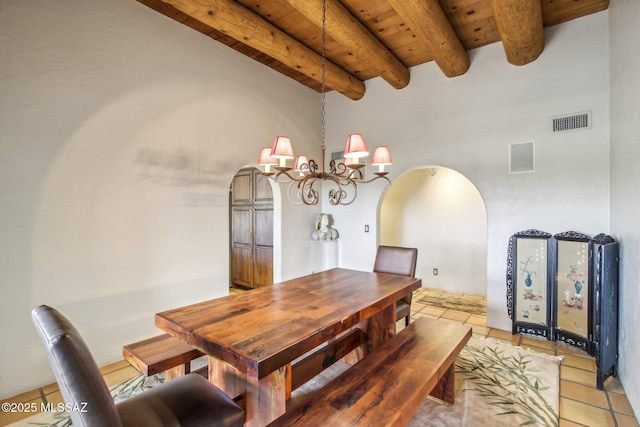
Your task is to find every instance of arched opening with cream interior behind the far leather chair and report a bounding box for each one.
[380,166,487,296]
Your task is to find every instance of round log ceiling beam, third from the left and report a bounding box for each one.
[389,0,470,77]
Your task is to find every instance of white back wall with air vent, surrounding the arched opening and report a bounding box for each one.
[323,12,609,330]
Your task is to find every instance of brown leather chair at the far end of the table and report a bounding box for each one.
[373,245,418,326]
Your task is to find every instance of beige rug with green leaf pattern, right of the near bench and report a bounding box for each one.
[407,337,562,427]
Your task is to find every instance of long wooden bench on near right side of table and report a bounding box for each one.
[270,317,471,426]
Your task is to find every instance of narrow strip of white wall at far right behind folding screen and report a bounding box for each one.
[609,0,640,416]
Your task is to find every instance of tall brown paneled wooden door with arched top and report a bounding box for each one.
[229,168,273,288]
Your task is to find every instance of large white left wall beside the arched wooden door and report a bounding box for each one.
[0,0,320,398]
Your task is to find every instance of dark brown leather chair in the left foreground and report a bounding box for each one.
[31,305,244,427]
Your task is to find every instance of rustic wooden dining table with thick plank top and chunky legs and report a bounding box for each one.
[155,268,422,426]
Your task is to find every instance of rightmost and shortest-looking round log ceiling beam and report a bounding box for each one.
[491,0,544,65]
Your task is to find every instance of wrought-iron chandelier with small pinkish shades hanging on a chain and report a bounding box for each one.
[258,0,391,205]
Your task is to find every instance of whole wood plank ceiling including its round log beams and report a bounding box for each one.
[138,0,609,100]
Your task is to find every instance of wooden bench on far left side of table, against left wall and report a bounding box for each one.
[122,334,204,380]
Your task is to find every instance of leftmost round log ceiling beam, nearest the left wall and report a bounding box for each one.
[163,0,365,100]
